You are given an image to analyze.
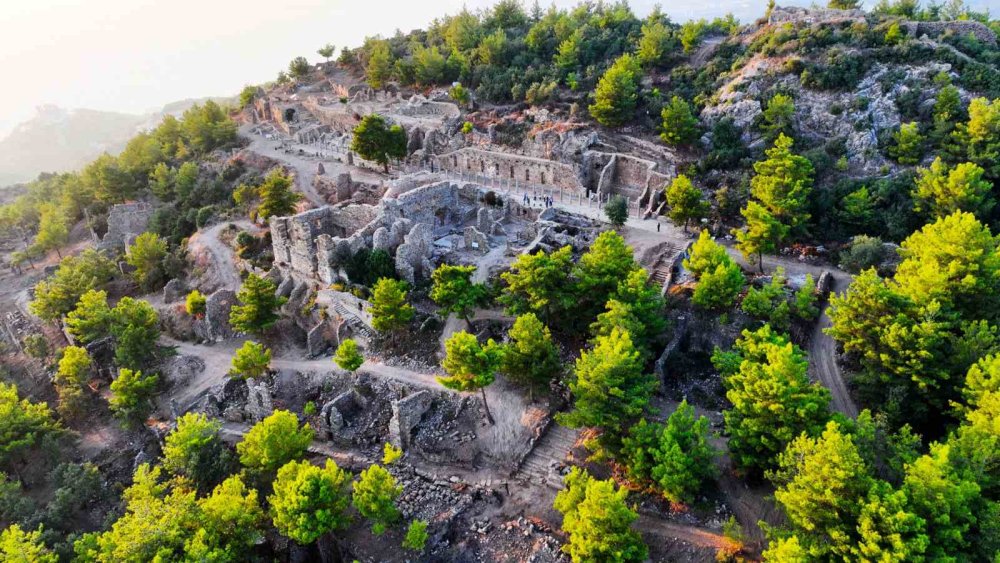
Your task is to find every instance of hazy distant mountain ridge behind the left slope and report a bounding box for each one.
[0,98,233,188]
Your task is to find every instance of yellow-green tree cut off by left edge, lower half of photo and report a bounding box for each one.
[0,383,62,469]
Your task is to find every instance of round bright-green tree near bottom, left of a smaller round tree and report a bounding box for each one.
[268,460,351,545]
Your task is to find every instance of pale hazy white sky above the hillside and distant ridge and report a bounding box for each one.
[0,0,990,136]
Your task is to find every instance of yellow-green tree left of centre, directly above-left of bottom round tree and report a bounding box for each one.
[236,410,314,473]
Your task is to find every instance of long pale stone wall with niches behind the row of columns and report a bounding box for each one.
[436,148,583,195]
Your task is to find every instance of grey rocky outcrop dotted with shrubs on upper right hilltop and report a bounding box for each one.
[701,8,996,176]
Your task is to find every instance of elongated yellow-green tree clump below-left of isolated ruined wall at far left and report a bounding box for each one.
[28,249,115,322]
